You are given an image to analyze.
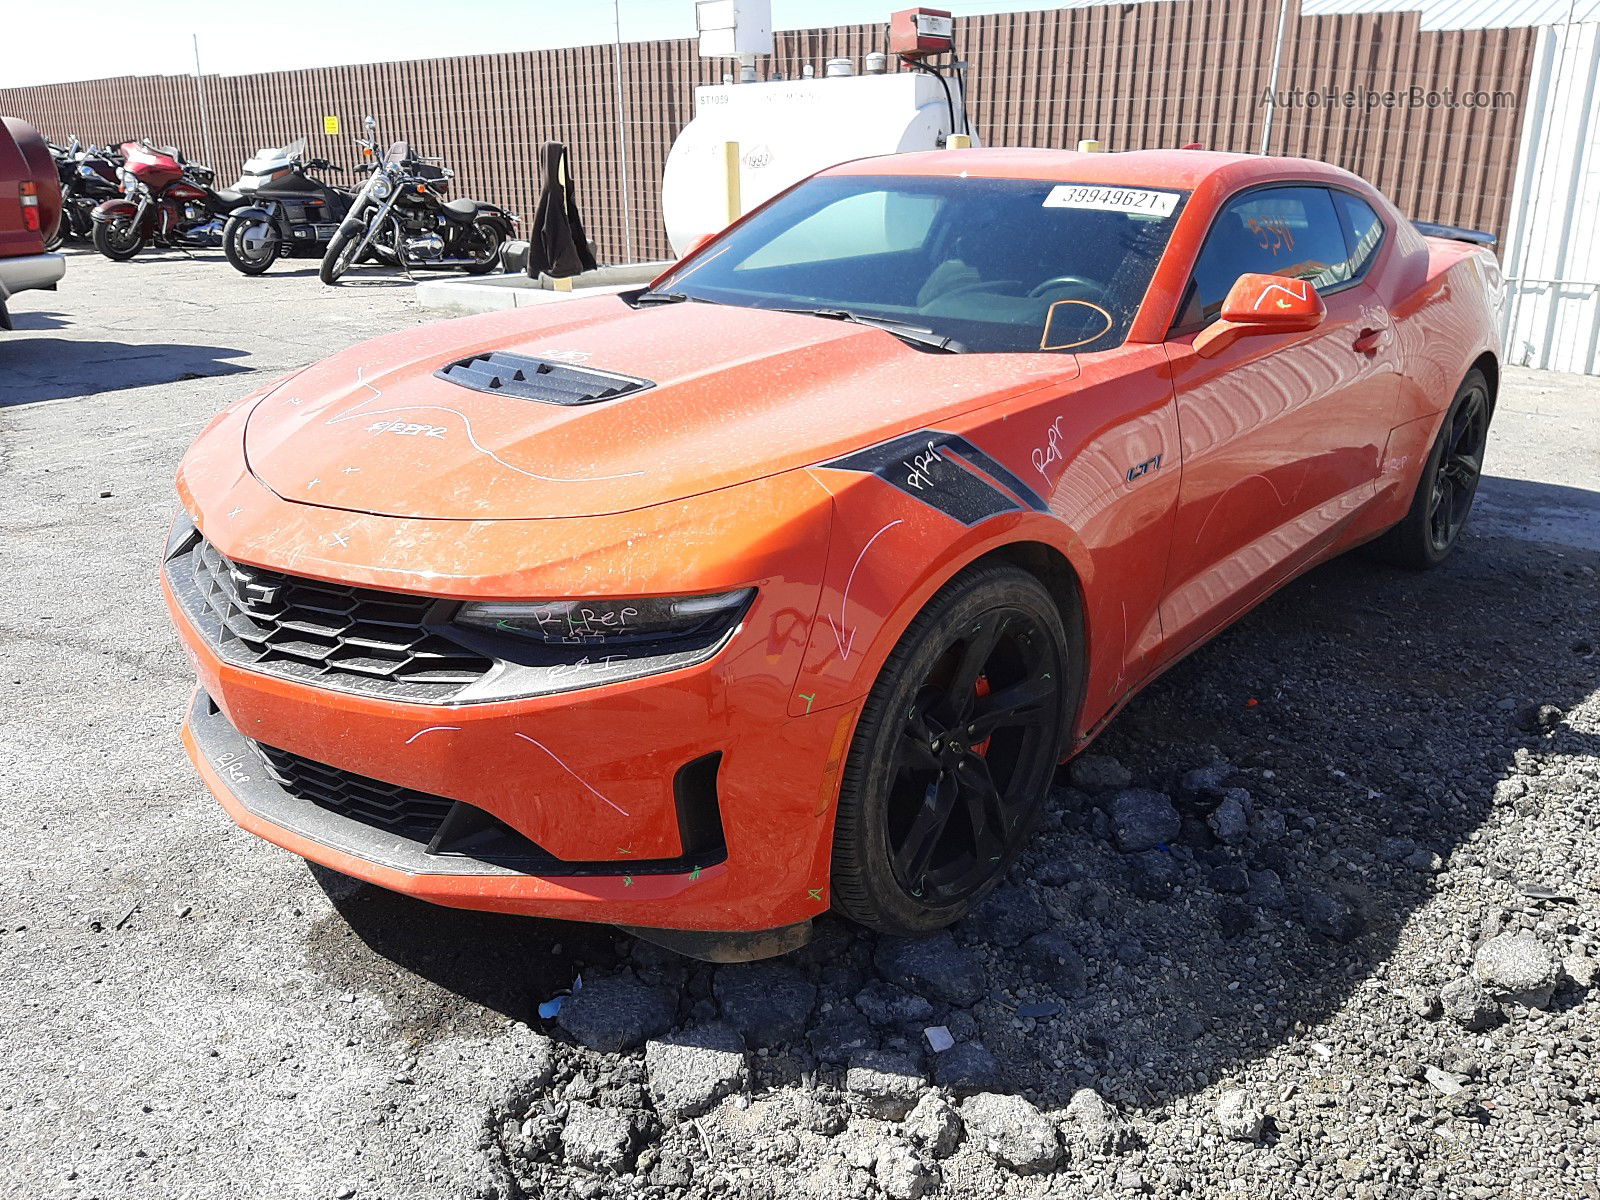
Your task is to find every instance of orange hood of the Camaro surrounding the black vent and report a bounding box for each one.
[245,296,1078,520]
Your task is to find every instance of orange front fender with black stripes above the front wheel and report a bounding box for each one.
[790,346,1181,734]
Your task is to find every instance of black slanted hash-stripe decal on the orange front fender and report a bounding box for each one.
[822,430,1045,525]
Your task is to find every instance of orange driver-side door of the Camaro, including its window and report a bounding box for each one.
[1162,184,1397,653]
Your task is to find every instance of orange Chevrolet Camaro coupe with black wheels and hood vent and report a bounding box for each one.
[162,149,1502,958]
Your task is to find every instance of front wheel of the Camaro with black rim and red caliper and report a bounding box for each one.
[832,565,1082,938]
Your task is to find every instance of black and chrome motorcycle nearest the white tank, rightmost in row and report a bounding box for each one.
[317,141,517,285]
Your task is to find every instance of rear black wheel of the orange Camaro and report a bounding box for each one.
[1370,368,1494,571]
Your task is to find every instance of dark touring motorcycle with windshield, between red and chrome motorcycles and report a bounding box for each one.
[222,138,355,275]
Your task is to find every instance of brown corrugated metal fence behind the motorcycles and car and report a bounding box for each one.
[0,0,1534,262]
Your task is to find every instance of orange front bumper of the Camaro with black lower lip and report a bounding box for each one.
[163,598,856,933]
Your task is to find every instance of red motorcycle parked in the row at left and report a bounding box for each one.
[91,139,246,262]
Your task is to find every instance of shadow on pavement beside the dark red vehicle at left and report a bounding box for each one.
[0,339,251,408]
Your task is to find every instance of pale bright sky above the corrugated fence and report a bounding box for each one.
[0,0,1082,88]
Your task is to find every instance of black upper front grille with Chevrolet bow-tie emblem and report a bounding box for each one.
[166,538,494,704]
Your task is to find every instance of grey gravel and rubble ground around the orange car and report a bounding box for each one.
[0,254,1600,1200]
